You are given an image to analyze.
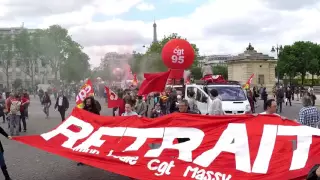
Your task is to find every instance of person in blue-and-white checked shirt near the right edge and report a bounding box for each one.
[299,96,320,127]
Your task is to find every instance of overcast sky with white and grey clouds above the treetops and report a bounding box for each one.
[0,0,320,66]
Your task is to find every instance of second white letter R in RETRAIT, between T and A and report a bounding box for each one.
[145,128,204,162]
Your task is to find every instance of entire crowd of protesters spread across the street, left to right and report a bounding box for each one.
[0,82,320,180]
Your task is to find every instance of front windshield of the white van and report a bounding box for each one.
[208,86,247,101]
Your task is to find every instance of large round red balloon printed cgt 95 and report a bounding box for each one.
[161,39,195,69]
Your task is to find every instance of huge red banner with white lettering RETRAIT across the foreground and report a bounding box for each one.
[14,108,320,180]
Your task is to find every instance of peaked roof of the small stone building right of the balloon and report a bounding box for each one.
[228,43,275,61]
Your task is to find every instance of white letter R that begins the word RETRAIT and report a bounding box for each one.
[41,116,94,149]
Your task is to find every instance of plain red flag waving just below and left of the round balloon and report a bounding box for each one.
[138,70,171,95]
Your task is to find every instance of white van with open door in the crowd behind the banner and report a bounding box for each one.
[185,83,251,115]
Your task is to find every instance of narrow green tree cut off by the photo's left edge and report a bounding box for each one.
[0,35,14,88]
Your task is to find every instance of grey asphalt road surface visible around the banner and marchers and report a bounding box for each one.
[0,99,308,180]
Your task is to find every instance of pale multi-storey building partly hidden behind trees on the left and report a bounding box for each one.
[0,26,56,89]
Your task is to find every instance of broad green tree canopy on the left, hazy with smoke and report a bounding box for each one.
[8,25,90,85]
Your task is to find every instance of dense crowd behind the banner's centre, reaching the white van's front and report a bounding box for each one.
[113,87,224,118]
